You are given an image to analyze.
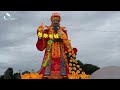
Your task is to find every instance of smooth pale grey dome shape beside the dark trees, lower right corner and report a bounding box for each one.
[91,66,120,79]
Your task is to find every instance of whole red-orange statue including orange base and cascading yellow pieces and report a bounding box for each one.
[21,13,90,79]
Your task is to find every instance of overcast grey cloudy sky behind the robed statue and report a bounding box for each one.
[0,11,120,75]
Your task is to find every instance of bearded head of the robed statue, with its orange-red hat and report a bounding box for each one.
[51,13,61,30]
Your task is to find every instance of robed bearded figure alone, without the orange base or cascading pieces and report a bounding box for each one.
[36,13,77,79]
